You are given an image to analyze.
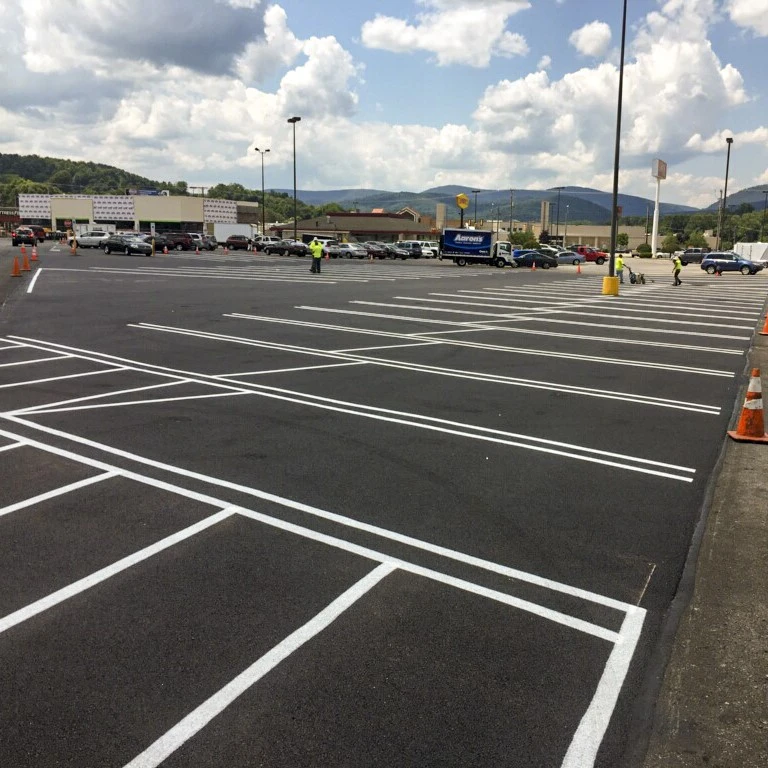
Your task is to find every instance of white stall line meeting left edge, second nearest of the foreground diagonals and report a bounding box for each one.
[0,507,235,634]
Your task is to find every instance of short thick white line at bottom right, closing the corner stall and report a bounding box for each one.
[561,608,645,768]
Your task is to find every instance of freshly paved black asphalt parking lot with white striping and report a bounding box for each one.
[0,246,768,768]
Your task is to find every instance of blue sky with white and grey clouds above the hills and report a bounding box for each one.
[0,0,768,205]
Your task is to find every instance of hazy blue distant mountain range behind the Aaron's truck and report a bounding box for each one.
[274,185,696,224]
